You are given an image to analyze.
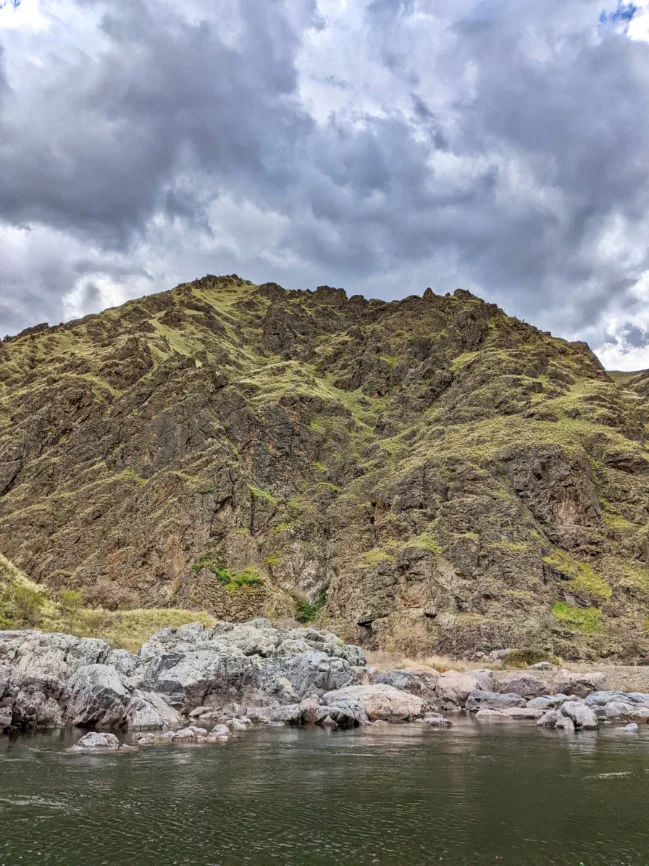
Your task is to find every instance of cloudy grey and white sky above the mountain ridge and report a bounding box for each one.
[0,0,649,369]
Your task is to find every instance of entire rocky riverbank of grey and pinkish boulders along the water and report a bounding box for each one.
[0,619,649,750]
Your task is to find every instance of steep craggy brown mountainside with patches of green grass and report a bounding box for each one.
[0,276,649,658]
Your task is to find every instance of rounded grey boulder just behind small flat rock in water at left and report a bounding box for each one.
[61,665,130,728]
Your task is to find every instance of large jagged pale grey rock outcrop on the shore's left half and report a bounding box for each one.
[0,619,364,729]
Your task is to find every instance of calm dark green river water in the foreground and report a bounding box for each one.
[0,721,649,866]
